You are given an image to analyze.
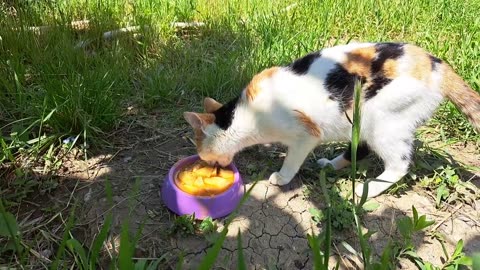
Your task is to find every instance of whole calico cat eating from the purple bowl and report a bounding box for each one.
[184,43,480,197]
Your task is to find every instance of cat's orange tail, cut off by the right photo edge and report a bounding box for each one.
[441,63,480,132]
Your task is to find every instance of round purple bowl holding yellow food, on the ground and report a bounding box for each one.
[161,155,244,219]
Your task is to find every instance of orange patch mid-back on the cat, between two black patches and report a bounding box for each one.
[342,46,376,78]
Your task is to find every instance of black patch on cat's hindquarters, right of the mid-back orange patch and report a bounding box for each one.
[365,43,404,100]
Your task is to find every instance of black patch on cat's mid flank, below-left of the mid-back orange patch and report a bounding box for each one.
[325,64,362,111]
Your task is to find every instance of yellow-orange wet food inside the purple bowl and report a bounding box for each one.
[175,161,234,196]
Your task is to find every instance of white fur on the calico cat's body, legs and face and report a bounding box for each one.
[195,43,450,197]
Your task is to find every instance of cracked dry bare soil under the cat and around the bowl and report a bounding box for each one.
[63,125,480,269]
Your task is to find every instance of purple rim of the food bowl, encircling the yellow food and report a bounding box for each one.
[167,154,241,199]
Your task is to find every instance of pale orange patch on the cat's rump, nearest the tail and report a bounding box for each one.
[405,45,432,82]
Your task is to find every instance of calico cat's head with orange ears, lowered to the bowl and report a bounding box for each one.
[183,98,235,166]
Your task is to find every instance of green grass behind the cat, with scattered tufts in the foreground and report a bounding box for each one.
[0,0,480,269]
